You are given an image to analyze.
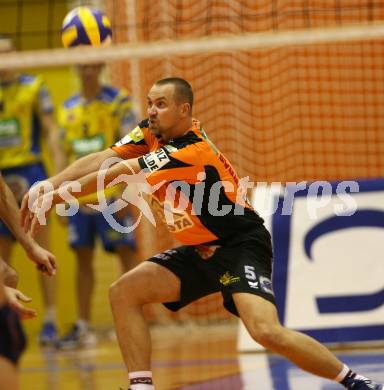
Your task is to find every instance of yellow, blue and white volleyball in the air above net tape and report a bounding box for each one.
[61,7,112,47]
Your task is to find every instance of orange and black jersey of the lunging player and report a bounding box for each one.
[112,120,263,245]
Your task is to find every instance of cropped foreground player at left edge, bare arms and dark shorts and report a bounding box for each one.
[0,174,56,390]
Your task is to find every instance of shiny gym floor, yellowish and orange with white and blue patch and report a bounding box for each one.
[20,324,384,390]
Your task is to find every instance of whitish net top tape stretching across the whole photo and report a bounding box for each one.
[0,22,384,69]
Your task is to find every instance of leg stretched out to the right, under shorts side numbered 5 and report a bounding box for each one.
[223,231,381,390]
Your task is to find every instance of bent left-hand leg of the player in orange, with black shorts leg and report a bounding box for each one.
[110,247,219,390]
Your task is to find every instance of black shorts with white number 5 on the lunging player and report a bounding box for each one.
[148,226,275,316]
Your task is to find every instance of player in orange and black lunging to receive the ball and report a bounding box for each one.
[22,78,383,390]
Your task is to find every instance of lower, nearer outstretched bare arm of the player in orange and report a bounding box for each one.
[23,158,141,235]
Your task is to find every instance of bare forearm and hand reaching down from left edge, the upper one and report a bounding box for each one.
[0,174,56,275]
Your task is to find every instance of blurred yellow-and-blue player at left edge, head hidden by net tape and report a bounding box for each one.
[0,36,64,345]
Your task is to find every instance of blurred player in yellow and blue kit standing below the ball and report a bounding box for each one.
[58,64,137,348]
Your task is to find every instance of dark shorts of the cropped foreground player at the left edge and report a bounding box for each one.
[0,305,26,365]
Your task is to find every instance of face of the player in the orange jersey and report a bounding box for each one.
[147,84,181,142]
